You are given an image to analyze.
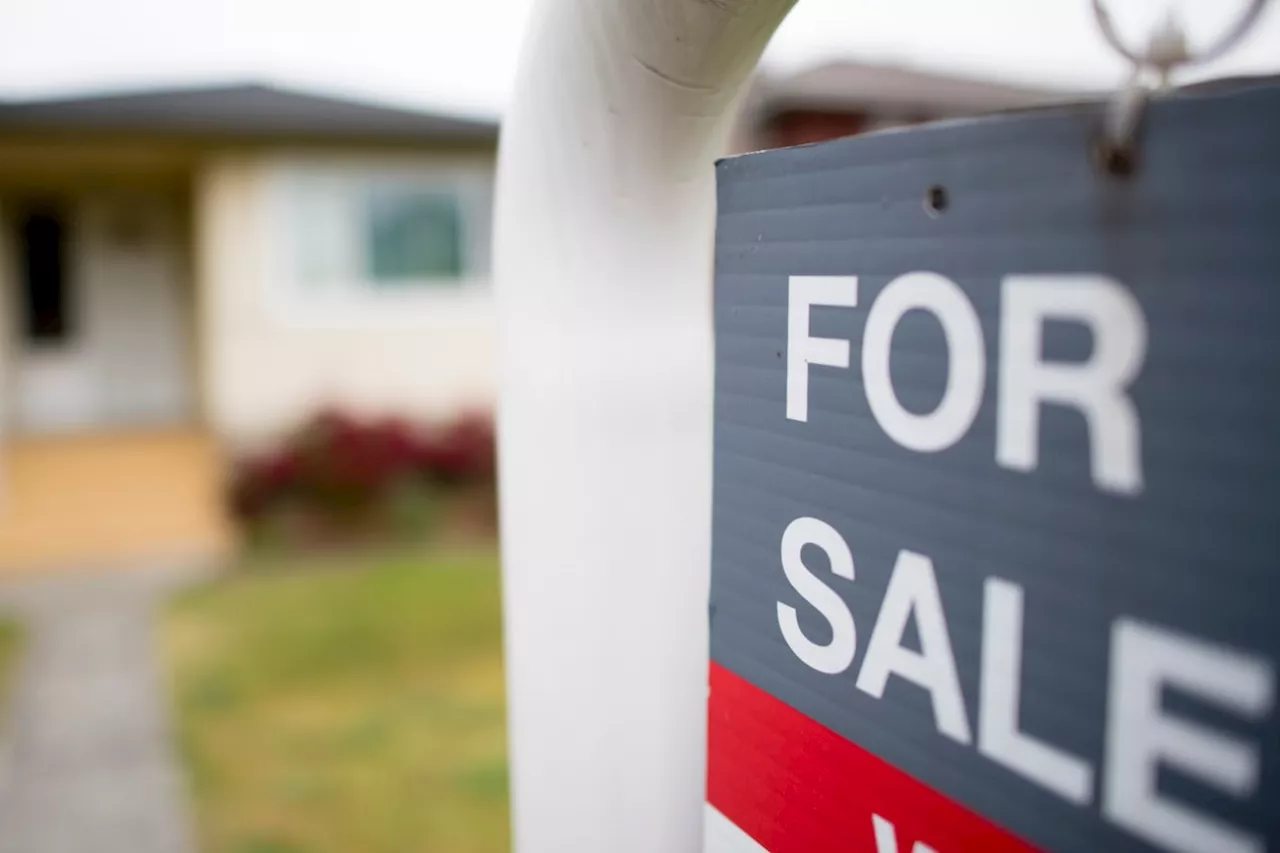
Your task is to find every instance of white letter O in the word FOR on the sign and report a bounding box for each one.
[863,273,987,453]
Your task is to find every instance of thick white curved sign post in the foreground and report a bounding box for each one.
[495,0,795,853]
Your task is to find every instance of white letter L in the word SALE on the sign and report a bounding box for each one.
[978,578,1093,806]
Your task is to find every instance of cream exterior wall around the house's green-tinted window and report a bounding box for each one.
[195,149,495,446]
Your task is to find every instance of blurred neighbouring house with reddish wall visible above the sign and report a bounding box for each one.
[732,61,1079,152]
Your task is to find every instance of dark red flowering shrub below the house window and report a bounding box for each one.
[230,410,495,530]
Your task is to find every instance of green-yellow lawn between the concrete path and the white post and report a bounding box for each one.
[164,552,509,853]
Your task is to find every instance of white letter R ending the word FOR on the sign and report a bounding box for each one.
[996,275,1147,494]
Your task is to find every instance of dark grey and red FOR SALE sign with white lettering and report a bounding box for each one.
[707,82,1280,853]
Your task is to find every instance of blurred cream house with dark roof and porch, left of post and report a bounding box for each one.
[0,86,497,570]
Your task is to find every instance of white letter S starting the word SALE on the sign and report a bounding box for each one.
[778,519,858,674]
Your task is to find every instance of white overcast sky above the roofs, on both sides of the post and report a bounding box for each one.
[0,0,1280,114]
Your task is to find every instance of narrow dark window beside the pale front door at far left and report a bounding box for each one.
[17,206,72,346]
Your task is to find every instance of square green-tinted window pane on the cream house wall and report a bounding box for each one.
[367,190,463,283]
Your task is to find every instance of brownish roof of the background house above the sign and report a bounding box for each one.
[756,61,1084,118]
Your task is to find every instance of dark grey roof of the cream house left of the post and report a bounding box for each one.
[0,85,498,142]
